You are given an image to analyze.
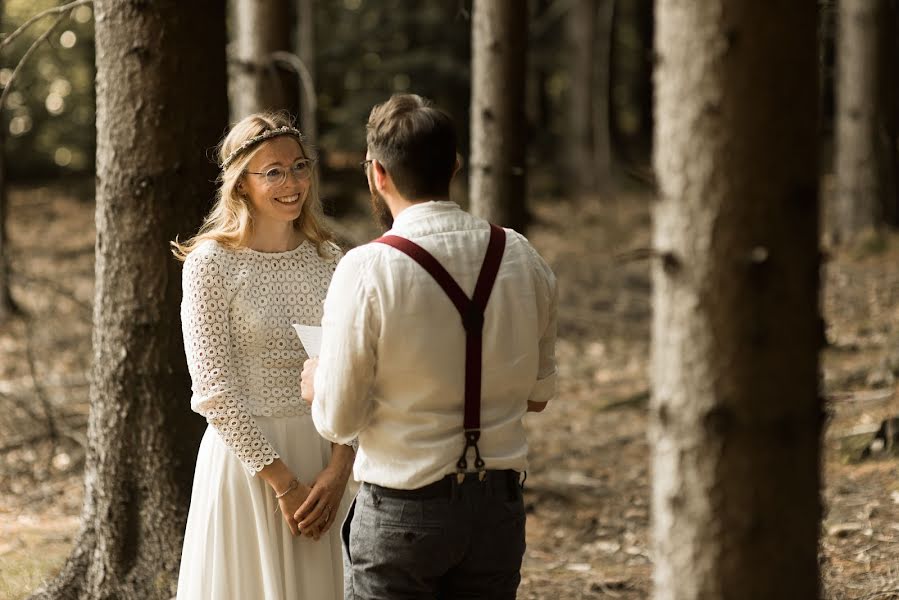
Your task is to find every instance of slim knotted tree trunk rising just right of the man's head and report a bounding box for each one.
[469,0,528,232]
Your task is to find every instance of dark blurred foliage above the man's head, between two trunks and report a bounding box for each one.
[316,0,471,153]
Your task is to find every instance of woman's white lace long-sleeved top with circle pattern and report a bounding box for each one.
[181,241,340,474]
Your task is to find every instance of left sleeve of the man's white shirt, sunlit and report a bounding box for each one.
[312,247,380,444]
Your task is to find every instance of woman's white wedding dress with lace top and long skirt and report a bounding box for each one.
[177,241,352,600]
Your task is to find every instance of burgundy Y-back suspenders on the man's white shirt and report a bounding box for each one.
[375,224,506,476]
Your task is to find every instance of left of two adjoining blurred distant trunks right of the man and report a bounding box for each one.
[565,0,605,194]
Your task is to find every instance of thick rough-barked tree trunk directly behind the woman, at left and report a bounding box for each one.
[35,0,227,600]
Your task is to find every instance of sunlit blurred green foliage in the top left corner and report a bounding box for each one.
[0,0,96,179]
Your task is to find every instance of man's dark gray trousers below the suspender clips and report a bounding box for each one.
[341,471,525,600]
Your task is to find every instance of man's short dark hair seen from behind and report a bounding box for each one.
[366,94,456,200]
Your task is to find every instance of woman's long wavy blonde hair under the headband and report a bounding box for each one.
[171,112,333,261]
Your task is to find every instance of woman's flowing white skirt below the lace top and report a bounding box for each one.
[178,416,356,600]
